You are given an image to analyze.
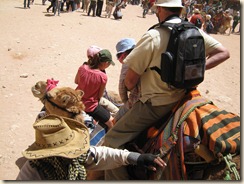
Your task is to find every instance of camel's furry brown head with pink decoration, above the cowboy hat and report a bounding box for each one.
[31,79,85,122]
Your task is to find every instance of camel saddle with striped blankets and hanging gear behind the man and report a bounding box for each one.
[126,90,240,180]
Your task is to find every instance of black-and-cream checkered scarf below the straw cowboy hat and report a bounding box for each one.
[30,153,88,180]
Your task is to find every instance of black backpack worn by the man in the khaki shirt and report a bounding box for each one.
[150,21,206,89]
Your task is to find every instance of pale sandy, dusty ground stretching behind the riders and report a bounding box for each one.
[0,0,240,180]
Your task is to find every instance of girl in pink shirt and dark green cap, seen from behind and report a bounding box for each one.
[75,49,114,128]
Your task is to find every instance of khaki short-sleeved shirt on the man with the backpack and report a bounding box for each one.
[124,19,220,106]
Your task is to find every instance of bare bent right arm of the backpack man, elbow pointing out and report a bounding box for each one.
[206,45,230,70]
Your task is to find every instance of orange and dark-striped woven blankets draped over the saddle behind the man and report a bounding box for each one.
[126,90,240,180]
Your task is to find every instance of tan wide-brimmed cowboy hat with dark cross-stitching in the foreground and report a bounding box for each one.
[22,115,90,159]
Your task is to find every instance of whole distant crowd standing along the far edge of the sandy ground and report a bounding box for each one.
[24,0,241,34]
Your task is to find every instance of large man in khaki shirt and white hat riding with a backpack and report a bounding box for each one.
[105,0,230,180]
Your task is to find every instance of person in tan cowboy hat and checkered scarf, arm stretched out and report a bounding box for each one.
[17,115,166,180]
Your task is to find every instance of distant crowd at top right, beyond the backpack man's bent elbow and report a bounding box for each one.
[181,0,241,33]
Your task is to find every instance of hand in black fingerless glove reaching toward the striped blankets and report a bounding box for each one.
[137,153,167,171]
